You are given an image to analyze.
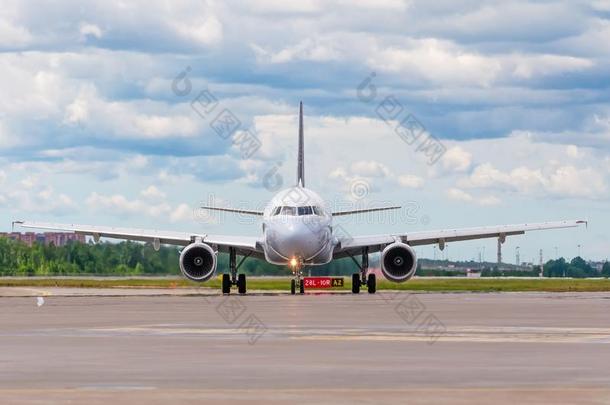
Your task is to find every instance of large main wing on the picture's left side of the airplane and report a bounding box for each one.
[13,221,263,256]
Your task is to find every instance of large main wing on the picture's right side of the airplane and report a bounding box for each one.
[335,220,587,257]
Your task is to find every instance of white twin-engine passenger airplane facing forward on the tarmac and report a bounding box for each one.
[14,102,587,294]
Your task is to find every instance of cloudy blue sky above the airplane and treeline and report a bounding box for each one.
[0,0,610,263]
